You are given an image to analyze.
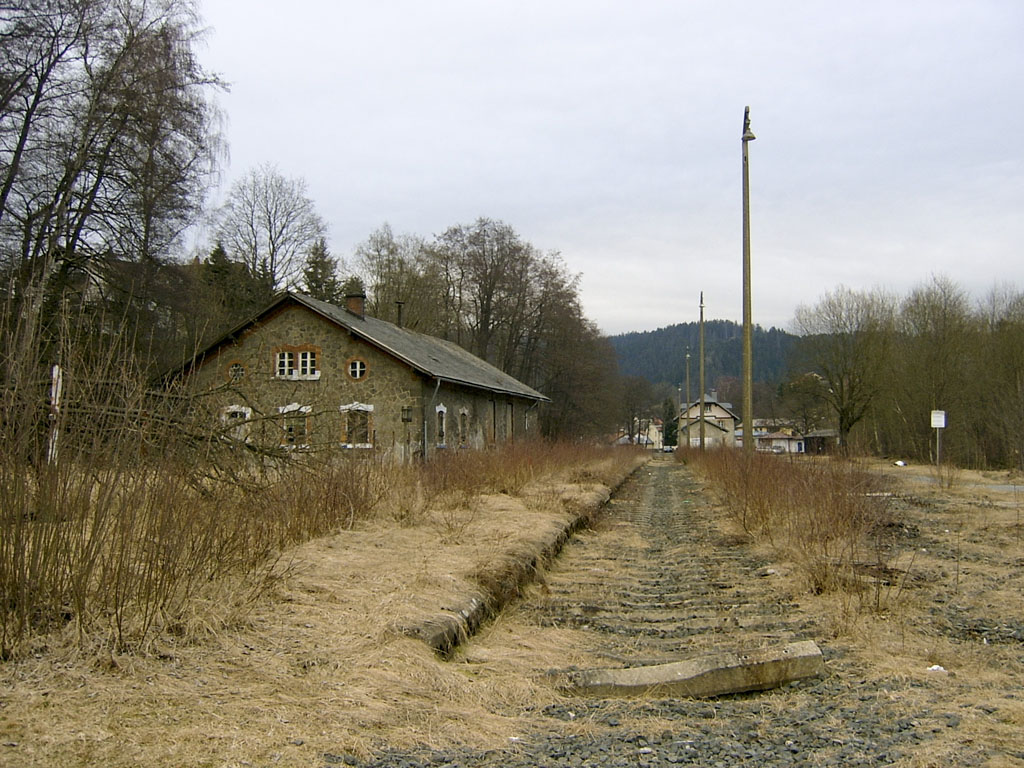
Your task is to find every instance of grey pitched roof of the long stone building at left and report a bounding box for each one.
[198,291,550,401]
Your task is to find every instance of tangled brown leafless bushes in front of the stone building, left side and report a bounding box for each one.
[0,301,626,657]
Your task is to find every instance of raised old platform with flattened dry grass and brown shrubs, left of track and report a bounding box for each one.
[0,443,644,766]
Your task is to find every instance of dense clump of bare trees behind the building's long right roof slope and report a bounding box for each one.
[356,218,621,436]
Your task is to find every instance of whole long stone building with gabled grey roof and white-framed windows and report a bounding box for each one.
[182,292,549,460]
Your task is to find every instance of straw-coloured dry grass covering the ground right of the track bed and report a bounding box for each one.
[675,450,1024,768]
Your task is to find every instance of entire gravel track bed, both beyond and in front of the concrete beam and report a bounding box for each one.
[361,457,991,768]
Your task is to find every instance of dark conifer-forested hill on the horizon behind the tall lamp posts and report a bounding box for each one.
[609,321,797,392]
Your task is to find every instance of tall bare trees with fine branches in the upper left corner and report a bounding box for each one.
[0,0,218,366]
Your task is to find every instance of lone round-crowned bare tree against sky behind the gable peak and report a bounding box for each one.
[214,164,327,289]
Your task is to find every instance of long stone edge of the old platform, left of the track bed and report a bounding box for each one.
[402,462,646,656]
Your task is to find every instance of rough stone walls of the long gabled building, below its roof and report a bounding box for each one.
[191,304,539,459]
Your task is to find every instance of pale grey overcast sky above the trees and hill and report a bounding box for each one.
[200,0,1024,334]
